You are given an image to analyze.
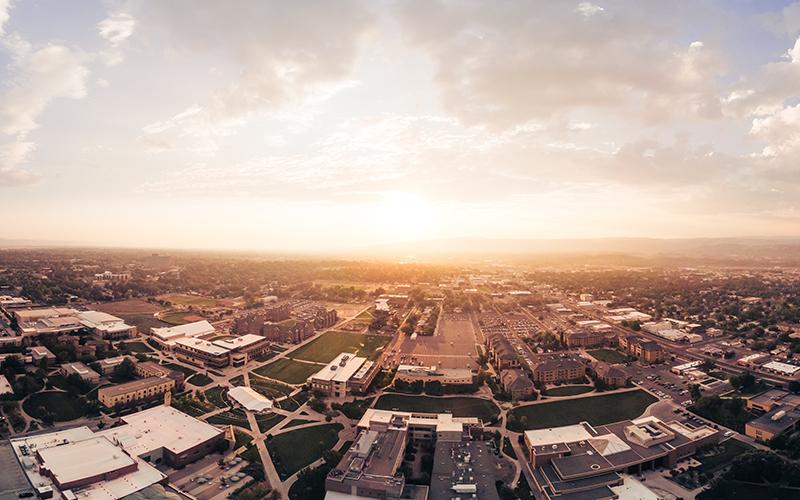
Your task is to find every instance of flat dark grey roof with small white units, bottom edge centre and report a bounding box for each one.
[428,441,500,500]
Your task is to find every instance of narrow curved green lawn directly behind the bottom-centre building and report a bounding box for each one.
[375,394,500,422]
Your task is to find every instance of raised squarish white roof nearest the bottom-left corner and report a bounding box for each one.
[38,436,135,484]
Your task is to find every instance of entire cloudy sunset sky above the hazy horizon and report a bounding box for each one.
[0,0,800,251]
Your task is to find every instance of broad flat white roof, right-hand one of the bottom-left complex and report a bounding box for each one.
[98,406,222,456]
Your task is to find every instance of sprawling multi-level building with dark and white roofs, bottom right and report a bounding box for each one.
[524,417,721,499]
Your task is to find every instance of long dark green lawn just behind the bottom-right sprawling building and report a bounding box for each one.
[507,390,658,431]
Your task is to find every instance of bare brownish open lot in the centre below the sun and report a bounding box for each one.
[399,314,478,370]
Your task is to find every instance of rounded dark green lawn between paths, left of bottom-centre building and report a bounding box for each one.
[267,424,342,480]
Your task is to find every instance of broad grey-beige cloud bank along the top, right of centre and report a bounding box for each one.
[399,1,725,127]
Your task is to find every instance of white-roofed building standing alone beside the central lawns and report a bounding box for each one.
[308,352,379,398]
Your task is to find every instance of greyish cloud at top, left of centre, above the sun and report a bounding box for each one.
[135,0,373,137]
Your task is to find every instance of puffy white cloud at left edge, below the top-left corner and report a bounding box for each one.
[0,44,89,137]
